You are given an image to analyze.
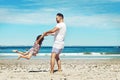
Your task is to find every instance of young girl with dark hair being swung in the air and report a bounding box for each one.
[13,35,44,60]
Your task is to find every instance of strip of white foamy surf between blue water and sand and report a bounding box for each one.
[0,52,120,60]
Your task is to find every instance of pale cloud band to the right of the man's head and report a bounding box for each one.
[66,14,120,28]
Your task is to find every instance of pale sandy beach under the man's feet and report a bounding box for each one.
[0,59,120,80]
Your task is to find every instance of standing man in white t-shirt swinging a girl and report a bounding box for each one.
[43,13,66,73]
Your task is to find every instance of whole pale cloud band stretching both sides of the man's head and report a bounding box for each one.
[0,8,120,28]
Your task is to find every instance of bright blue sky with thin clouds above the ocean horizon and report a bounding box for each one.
[0,0,120,46]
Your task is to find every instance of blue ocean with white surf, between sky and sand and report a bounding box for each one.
[0,46,120,59]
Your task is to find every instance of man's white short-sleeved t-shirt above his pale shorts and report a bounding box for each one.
[53,22,66,49]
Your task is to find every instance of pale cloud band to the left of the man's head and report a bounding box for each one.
[0,8,55,24]
